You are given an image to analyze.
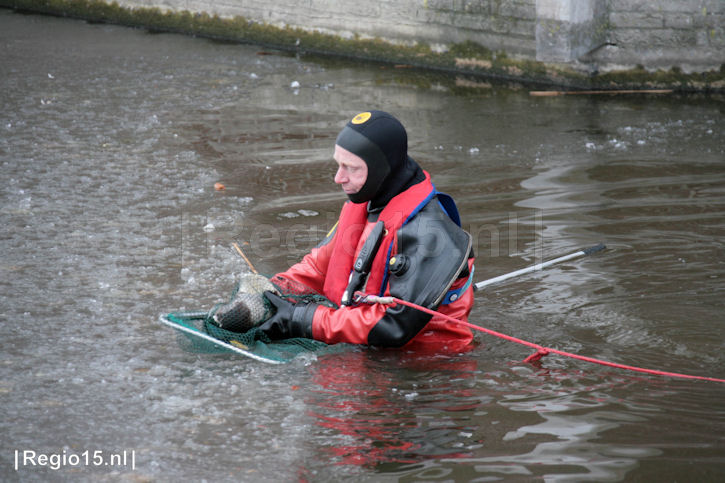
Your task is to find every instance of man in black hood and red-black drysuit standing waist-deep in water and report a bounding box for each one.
[221,111,474,350]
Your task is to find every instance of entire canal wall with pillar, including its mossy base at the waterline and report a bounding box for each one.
[0,0,725,92]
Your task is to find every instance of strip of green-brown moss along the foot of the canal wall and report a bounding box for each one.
[0,0,725,91]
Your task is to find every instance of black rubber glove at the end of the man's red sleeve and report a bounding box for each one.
[259,292,318,340]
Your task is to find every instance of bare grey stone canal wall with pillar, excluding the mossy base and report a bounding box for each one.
[110,0,725,72]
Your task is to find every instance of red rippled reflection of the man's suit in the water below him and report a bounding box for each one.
[306,352,481,468]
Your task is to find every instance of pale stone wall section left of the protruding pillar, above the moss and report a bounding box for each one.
[117,0,536,58]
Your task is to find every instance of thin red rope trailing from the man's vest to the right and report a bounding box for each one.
[370,296,725,382]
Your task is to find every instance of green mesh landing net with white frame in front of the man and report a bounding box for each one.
[162,276,353,362]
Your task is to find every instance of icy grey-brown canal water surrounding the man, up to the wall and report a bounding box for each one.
[0,10,725,482]
